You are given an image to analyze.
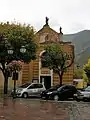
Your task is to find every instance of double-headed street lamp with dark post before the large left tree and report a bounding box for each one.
[7,46,26,98]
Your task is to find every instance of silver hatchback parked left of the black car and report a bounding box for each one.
[11,83,45,98]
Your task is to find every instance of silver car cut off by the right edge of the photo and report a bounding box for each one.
[75,86,90,101]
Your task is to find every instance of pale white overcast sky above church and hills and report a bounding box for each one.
[0,0,90,34]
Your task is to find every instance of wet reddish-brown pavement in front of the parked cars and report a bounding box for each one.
[0,97,90,120]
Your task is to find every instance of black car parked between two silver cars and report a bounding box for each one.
[41,85,77,101]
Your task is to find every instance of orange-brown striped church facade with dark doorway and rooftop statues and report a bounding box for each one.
[21,18,74,88]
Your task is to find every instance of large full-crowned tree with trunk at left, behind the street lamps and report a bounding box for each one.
[0,22,37,94]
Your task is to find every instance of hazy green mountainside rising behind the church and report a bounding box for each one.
[63,30,90,66]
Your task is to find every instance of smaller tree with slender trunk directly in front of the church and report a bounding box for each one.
[41,44,74,85]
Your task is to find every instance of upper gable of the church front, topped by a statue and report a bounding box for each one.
[36,17,62,44]
